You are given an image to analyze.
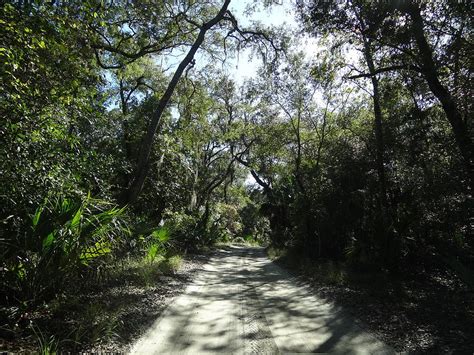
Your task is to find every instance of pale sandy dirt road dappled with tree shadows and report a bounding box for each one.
[131,246,393,354]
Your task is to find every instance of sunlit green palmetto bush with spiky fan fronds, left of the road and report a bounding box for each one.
[1,195,130,304]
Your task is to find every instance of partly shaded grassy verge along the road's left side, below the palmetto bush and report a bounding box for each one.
[2,255,187,354]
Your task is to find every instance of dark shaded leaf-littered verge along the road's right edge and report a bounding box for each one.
[267,246,474,353]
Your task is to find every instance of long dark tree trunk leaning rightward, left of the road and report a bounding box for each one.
[123,0,230,204]
